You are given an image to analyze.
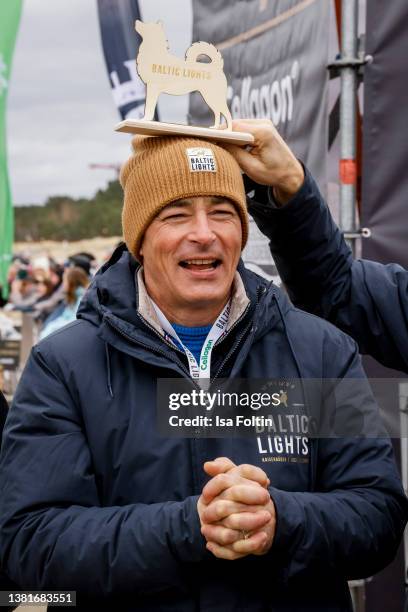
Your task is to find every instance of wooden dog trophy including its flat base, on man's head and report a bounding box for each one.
[115,20,254,145]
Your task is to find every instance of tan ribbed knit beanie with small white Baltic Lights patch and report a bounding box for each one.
[120,136,248,259]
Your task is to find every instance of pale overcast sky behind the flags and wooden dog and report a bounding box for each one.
[7,0,192,205]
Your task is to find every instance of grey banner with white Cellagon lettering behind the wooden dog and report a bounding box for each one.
[189,0,330,189]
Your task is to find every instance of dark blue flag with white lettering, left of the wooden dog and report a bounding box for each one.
[98,0,145,119]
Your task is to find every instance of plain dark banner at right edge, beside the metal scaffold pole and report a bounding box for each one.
[362,0,408,268]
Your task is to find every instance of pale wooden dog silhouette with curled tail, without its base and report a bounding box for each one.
[135,20,232,130]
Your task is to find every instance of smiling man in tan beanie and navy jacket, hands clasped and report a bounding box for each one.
[0,137,407,612]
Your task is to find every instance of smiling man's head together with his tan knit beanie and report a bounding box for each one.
[121,138,248,326]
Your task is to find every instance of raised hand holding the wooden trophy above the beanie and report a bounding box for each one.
[223,119,305,204]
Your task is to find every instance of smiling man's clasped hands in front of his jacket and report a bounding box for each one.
[197,457,276,560]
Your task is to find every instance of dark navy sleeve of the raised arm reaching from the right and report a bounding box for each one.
[250,170,408,372]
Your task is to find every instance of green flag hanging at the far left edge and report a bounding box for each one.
[0,0,22,297]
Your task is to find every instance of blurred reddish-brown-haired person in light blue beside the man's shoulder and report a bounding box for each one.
[40,266,89,339]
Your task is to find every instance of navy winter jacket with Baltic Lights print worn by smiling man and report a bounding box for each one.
[0,246,407,612]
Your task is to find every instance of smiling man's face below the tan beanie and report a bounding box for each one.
[140,196,242,325]
